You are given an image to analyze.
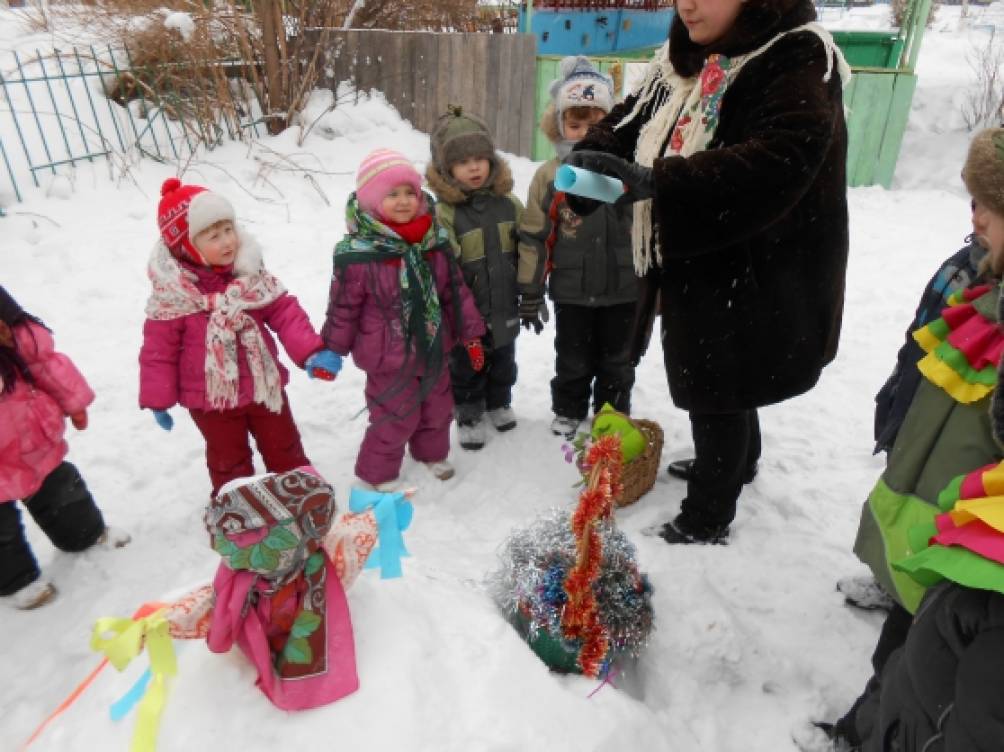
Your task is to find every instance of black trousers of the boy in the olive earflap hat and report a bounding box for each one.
[450,334,517,423]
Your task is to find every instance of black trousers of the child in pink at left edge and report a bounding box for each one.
[0,462,104,595]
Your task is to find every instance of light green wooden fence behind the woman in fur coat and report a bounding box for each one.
[533,0,932,188]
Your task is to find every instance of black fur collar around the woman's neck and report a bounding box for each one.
[670,0,816,76]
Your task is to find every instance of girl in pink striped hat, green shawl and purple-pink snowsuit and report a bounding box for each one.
[321,150,485,490]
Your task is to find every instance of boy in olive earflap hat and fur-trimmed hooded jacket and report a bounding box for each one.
[426,107,523,449]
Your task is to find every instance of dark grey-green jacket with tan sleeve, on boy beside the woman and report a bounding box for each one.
[518,159,638,306]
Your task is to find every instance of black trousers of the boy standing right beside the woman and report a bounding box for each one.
[551,303,635,420]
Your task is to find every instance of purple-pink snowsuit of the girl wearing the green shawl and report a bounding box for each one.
[320,241,485,485]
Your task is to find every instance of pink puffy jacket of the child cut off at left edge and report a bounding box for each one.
[0,321,94,501]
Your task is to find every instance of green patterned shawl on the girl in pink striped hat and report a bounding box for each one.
[334,193,450,362]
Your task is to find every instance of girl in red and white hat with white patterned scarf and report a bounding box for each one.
[140,178,341,496]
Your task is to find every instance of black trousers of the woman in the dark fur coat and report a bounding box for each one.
[679,410,760,537]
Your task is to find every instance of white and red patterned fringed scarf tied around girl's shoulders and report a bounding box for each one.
[141,240,286,413]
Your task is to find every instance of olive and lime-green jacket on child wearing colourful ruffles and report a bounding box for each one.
[854,284,1004,612]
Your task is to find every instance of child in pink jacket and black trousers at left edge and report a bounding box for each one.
[0,287,129,608]
